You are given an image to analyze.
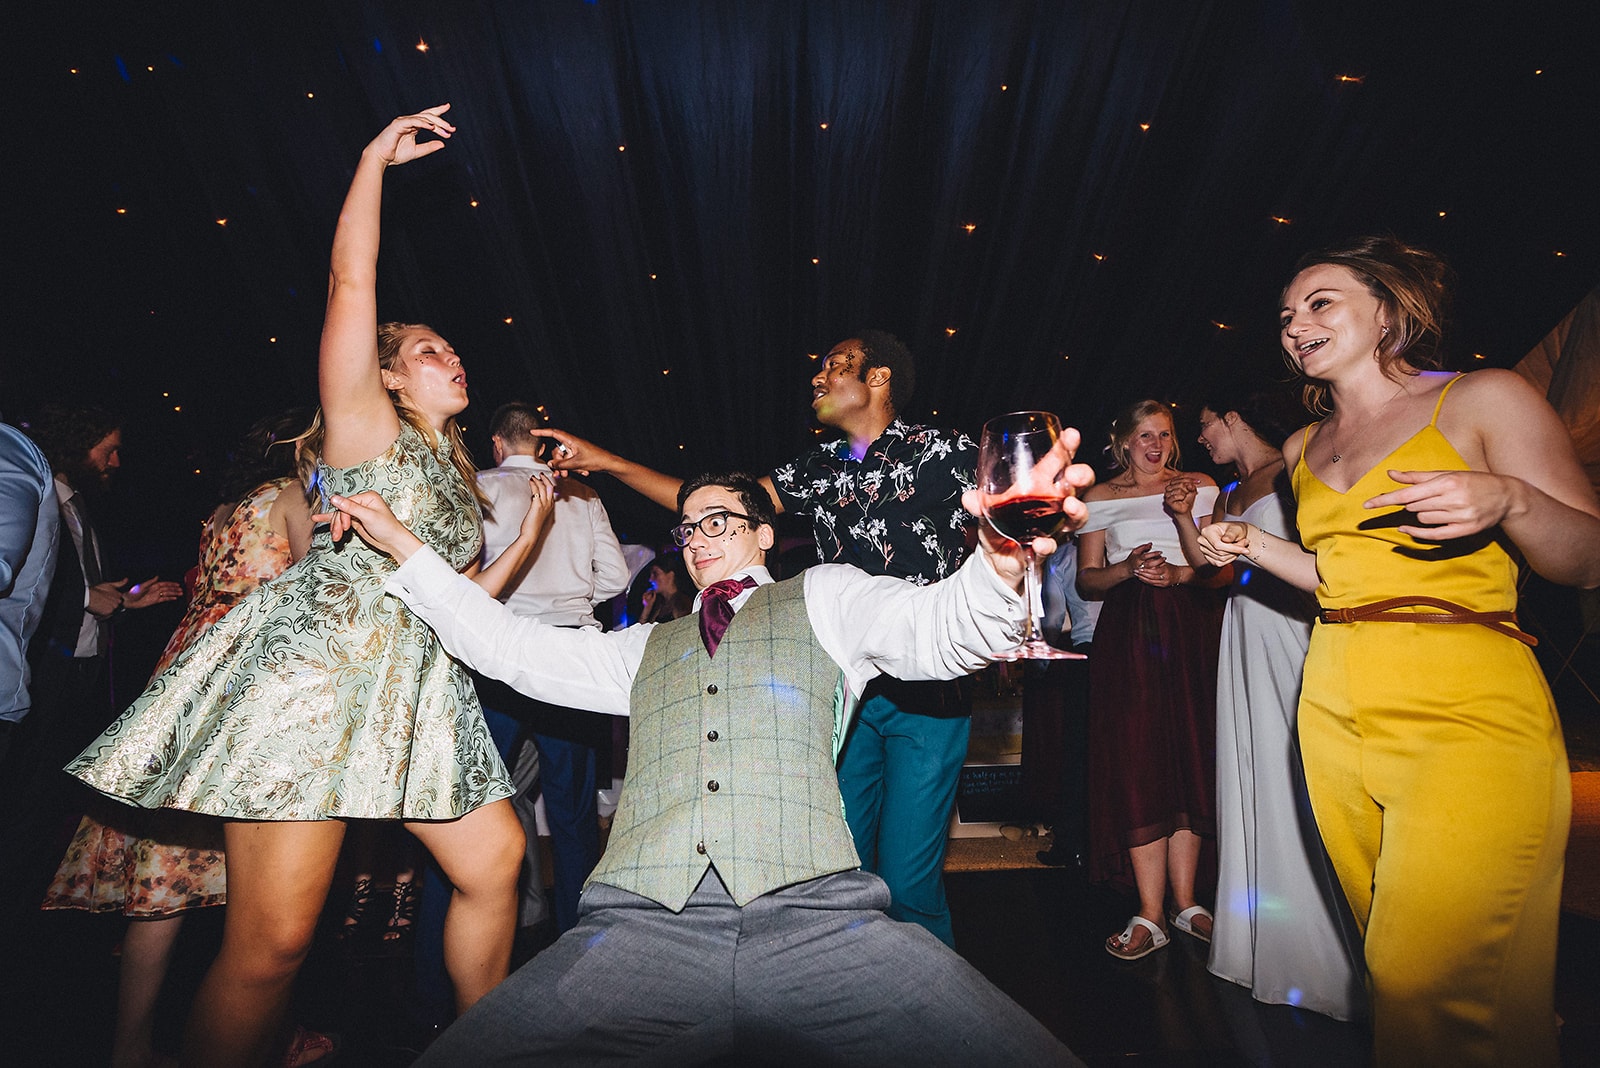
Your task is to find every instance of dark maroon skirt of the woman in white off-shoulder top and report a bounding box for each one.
[1088,579,1222,881]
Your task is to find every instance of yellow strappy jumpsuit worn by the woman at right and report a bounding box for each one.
[1293,382,1571,1068]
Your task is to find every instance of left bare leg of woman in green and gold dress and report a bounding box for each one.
[184,820,344,1068]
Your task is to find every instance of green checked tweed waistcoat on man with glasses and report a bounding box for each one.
[589,579,861,911]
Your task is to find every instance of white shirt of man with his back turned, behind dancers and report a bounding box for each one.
[478,454,632,627]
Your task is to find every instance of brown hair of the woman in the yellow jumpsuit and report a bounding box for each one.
[1280,237,1451,416]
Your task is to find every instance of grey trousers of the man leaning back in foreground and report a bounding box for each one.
[416,870,1082,1068]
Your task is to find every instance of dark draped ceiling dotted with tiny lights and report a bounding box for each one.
[0,0,1600,543]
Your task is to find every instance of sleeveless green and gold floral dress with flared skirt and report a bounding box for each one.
[67,425,512,820]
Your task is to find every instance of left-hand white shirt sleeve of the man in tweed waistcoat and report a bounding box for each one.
[384,548,651,716]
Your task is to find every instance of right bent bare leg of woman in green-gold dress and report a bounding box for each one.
[406,799,523,1012]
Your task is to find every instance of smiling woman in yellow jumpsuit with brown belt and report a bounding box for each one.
[1202,238,1600,1066]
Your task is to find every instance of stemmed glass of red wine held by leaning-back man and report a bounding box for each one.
[978,411,1083,660]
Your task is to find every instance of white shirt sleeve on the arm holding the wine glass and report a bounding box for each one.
[805,553,1024,695]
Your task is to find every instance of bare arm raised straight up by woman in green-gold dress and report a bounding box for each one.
[317,104,454,467]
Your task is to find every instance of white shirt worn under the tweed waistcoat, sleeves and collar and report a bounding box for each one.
[384,548,1022,716]
